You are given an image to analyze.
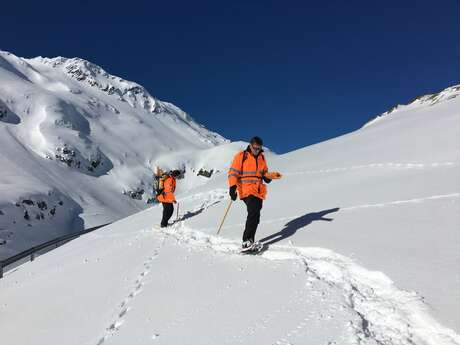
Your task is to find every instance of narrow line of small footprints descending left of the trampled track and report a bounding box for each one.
[96,247,160,345]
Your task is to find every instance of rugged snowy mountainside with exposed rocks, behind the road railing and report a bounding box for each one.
[0,51,227,258]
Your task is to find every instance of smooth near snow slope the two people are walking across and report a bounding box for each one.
[0,80,460,345]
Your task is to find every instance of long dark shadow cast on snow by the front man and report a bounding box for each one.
[260,207,340,246]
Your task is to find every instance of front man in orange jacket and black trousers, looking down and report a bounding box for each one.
[228,137,272,250]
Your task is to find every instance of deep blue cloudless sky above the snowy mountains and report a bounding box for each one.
[0,0,460,153]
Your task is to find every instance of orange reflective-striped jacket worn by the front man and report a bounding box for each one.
[228,148,268,199]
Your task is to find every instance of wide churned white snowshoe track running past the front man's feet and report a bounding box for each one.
[159,220,460,345]
